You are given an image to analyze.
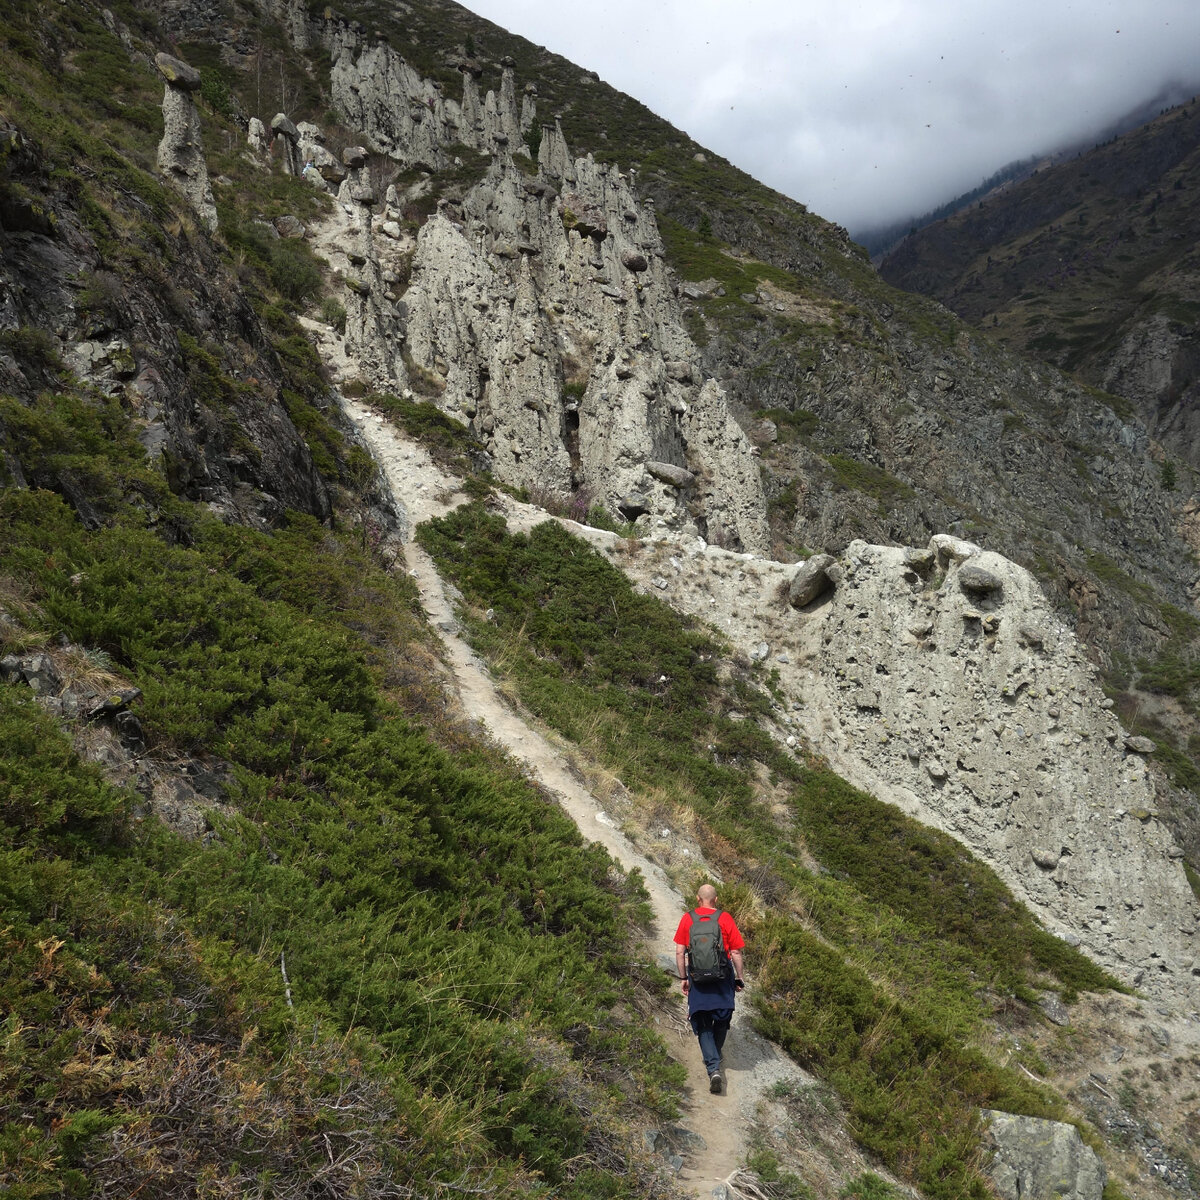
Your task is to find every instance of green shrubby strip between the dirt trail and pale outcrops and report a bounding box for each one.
[420,504,1114,1198]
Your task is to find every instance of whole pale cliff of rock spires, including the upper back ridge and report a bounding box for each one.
[296,9,768,551]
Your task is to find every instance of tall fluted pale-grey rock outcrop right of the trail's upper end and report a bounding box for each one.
[404,146,766,550]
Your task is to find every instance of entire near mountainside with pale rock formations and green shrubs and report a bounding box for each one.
[0,2,1198,1200]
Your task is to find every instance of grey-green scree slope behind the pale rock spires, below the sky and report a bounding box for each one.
[307,2,1195,681]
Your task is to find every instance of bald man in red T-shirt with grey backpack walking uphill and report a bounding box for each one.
[674,883,745,1094]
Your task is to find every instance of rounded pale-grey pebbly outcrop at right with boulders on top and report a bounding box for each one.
[793,539,1200,1001]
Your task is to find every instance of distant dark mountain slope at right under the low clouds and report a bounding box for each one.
[881,101,1200,470]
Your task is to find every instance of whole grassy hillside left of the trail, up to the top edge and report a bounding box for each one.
[0,6,678,1196]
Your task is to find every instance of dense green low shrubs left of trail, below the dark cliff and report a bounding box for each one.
[0,480,678,1195]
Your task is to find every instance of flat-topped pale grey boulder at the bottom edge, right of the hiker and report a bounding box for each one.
[984,1109,1108,1200]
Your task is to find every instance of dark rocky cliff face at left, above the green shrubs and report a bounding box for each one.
[0,119,330,524]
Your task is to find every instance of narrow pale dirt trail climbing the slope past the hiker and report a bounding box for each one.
[333,391,806,1198]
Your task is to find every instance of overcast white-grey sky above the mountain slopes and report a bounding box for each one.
[466,0,1200,232]
